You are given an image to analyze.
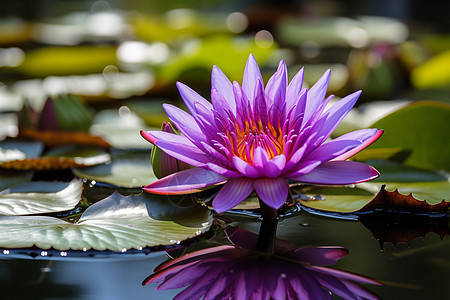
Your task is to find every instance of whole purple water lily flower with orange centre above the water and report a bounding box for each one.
[141,55,382,213]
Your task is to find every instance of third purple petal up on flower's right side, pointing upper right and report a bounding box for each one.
[313,91,361,145]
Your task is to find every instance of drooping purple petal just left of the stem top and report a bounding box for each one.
[213,178,253,214]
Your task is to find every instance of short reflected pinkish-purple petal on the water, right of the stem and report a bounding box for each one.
[293,247,348,266]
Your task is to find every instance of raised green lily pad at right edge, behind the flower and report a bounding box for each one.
[369,101,450,171]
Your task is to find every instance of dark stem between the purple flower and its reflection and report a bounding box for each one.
[256,200,278,254]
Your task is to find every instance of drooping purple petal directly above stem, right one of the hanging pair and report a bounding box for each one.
[253,178,289,209]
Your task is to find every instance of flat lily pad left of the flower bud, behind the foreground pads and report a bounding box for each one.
[72,151,157,188]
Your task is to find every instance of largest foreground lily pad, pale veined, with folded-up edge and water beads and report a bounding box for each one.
[0,192,213,252]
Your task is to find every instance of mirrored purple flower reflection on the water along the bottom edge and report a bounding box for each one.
[143,229,380,300]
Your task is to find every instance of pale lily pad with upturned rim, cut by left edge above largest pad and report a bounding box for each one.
[0,180,83,216]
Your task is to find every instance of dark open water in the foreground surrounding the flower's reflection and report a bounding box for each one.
[0,212,450,300]
